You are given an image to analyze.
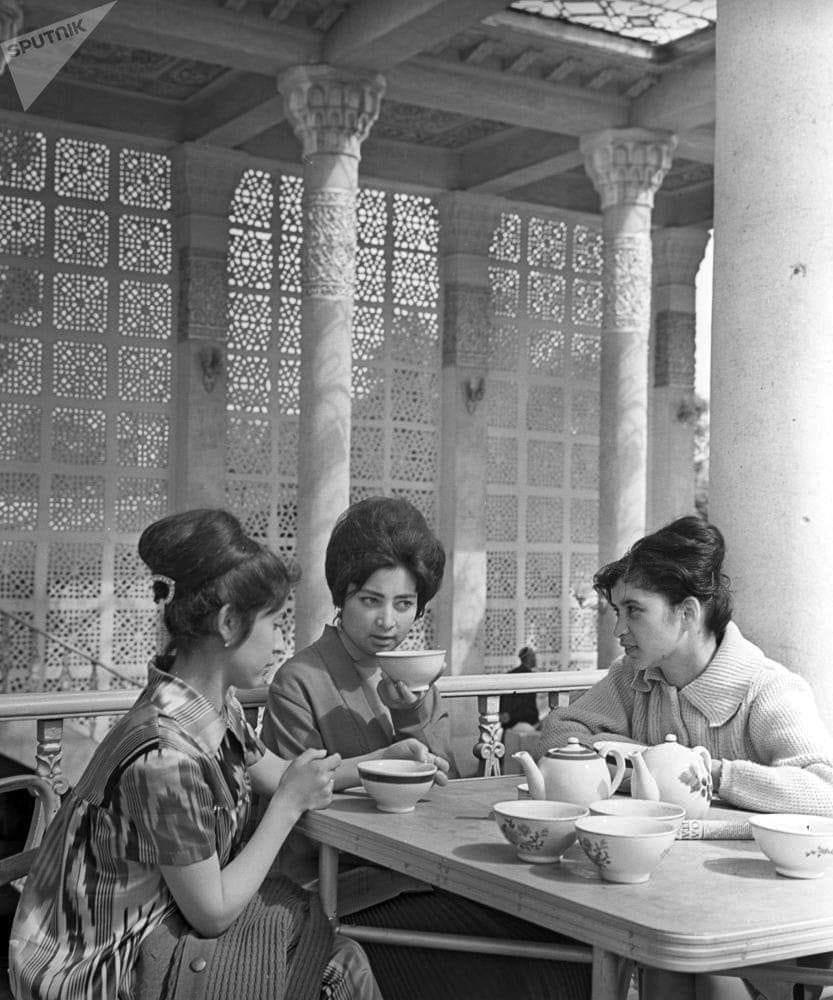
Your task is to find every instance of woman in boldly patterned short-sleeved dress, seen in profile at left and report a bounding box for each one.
[10,509,380,1000]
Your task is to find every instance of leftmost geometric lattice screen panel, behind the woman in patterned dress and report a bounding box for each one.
[0,121,174,692]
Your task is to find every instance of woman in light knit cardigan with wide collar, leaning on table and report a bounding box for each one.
[538,517,833,816]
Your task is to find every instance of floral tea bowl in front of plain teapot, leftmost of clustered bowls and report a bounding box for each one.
[492,799,587,864]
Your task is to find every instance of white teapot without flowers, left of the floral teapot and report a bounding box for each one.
[512,736,625,806]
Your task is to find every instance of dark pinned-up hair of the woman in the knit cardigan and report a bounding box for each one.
[593,515,732,642]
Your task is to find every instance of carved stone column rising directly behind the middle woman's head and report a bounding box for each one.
[278,65,385,648]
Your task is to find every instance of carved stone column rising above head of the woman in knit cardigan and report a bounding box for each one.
[581,129,676,667]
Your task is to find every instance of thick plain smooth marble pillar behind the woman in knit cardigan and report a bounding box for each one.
[709,0,833,728]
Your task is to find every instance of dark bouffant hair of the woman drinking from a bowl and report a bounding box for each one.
[324,497,445,618]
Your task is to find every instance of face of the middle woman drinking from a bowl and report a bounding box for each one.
[341,566,417,656]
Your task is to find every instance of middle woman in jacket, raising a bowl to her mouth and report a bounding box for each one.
[263,497,590,1000]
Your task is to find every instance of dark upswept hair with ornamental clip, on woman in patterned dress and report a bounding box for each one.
[139,508,300,660]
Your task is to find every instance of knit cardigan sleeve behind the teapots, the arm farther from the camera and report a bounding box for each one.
[537,659,634,756]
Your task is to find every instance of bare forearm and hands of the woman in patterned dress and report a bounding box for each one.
[161,750,339,937]
